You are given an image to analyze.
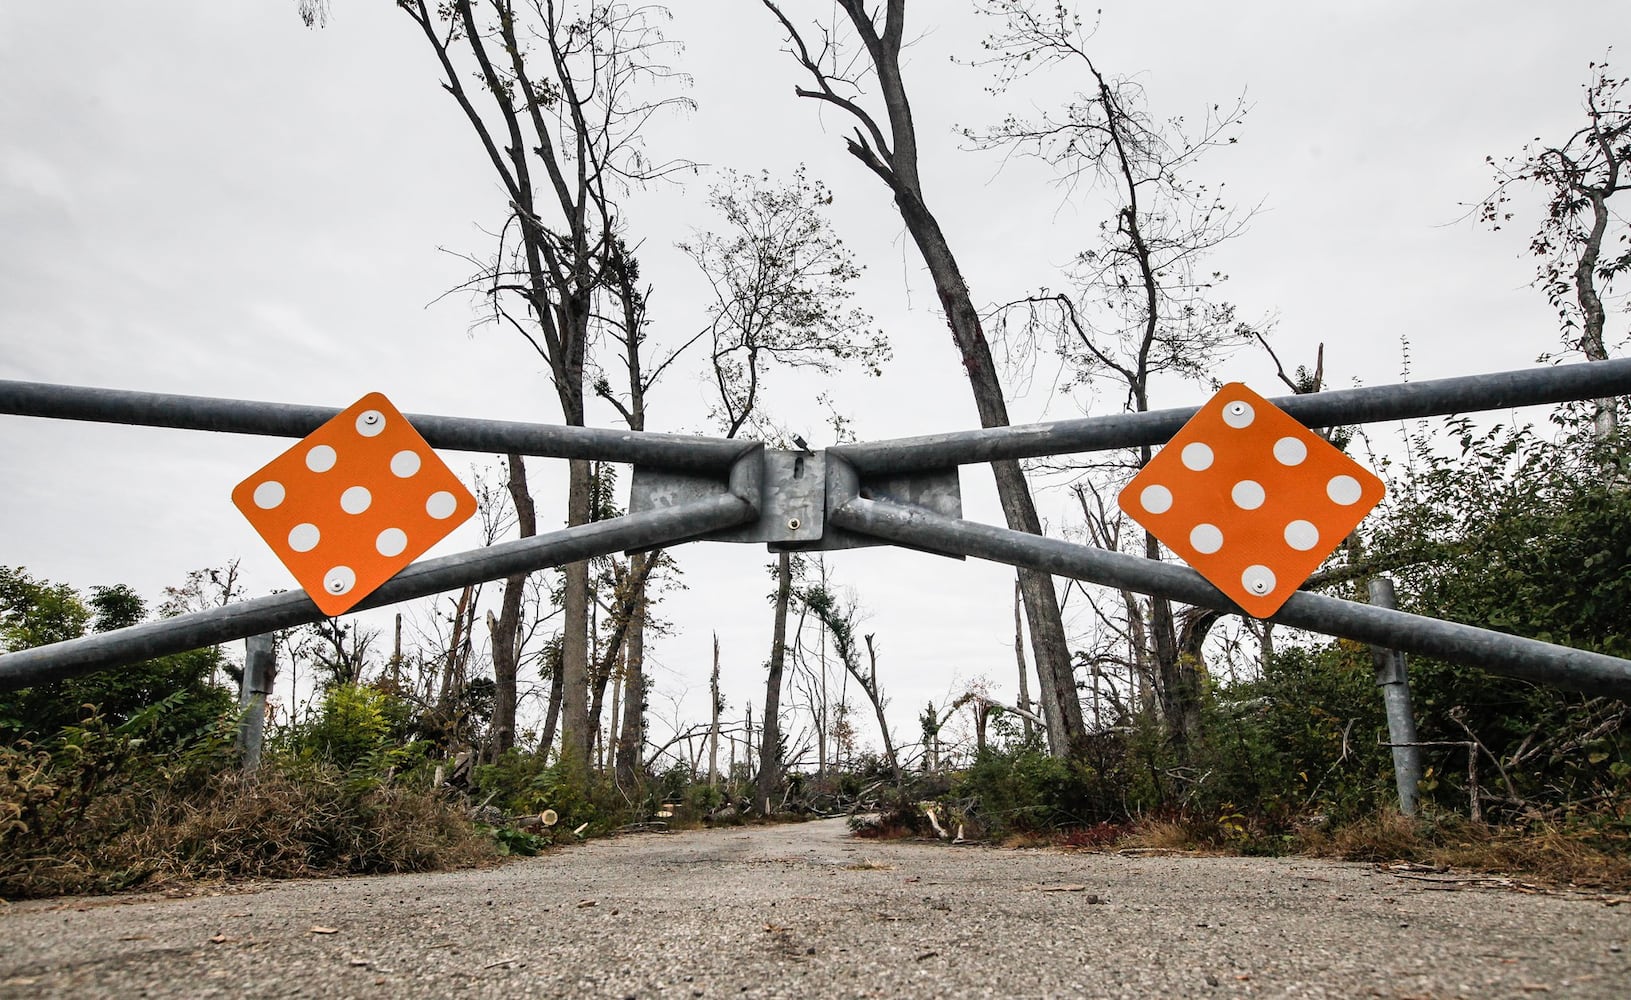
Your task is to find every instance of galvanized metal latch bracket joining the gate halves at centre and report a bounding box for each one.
[628,449,962,558]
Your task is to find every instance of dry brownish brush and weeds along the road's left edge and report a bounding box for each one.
[0,703,491,897]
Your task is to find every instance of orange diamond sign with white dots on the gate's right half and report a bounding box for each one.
[1117,382,1383,618]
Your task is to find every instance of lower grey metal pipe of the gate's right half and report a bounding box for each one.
[827,498,1631,698]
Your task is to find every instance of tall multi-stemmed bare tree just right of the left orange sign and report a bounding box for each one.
[398,0,687,763]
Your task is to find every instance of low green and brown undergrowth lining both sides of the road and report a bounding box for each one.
[0,409,1631,899]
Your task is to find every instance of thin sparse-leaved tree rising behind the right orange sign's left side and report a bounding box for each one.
[966,0,1254,742]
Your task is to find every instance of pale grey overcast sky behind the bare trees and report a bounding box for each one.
[0,0,1631,753]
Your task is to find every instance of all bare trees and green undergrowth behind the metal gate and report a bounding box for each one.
[0,0,1631,899]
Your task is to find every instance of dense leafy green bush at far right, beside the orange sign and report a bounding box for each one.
[1368,409,1631,819]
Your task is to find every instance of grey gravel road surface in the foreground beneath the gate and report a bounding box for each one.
[0,821,1631,1000]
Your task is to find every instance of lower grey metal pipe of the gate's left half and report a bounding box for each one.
[0,486,758,692]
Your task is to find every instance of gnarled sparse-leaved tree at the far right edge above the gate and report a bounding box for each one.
[1476,60,1631,440]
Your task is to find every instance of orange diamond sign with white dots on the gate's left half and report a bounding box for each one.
[232,393,476,615]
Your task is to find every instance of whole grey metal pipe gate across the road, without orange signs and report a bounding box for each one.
[0,359,1631,698]
